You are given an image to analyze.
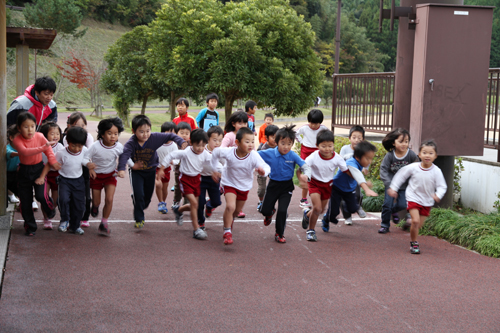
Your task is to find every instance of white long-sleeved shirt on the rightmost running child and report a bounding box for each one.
[391,162,448,207]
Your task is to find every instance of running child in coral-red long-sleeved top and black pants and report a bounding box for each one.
[12,112,61,236]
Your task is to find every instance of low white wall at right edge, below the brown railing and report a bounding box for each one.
[460,158,500,213]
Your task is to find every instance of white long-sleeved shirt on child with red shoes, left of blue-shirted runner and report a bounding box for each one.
[210,147,271,191]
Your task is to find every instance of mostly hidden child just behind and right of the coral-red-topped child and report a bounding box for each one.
[40,121,64,230]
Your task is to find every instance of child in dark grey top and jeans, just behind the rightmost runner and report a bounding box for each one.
[378,128,418,234]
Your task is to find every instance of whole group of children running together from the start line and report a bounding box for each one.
[9,90,446,253]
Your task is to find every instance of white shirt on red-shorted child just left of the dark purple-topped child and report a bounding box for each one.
[83,140,123,174]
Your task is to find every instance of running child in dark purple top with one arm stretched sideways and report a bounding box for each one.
[118,115,187,229]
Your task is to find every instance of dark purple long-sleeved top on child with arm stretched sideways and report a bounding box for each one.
[118,133,184,171]
